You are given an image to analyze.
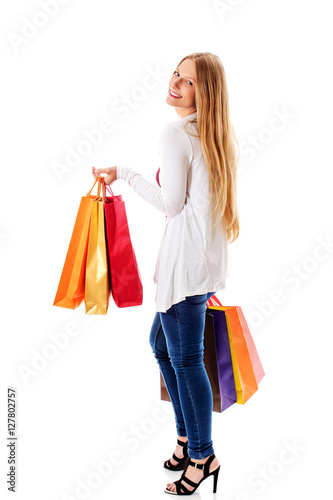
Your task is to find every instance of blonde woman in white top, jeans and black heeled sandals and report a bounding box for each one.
[93,52,239,495]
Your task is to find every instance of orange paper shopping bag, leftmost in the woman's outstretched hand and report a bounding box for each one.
[53,181,97,309]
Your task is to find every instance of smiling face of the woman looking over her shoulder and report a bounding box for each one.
[166,59,197,118]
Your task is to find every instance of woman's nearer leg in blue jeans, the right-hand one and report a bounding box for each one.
[159,293,214,460]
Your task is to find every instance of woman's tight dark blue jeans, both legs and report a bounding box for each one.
[149,292,215,459]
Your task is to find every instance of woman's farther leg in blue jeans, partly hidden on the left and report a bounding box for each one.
[149,312,187,438]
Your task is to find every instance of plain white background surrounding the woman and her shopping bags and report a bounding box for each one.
[0,0,333,500]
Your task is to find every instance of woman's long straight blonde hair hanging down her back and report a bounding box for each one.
[178,52,239,243]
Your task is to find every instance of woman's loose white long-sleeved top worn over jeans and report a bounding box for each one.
[117,112,229,312]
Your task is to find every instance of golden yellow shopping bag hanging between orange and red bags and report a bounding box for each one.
[85,177,110,314]
